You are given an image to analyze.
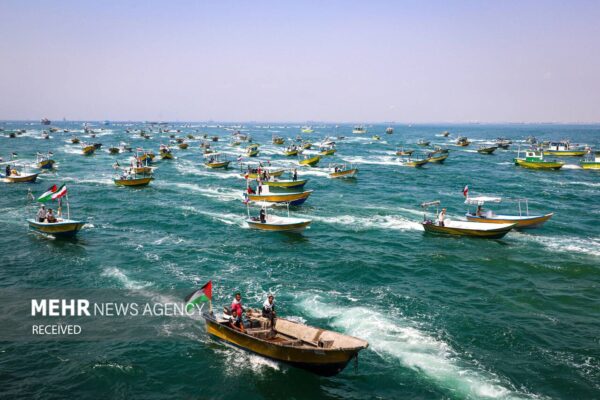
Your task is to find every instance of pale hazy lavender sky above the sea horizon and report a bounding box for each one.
[0,0,600,122]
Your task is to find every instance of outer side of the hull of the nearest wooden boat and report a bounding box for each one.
[204,316,358,376]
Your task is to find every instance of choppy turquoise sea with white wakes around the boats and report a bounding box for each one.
[0,122,600,399]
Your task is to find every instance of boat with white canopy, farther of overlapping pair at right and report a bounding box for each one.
[465,196,554,229]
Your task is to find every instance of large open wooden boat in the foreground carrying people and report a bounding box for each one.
[202,309,369,376]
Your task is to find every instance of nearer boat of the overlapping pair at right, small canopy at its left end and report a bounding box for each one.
[421,200,516,239]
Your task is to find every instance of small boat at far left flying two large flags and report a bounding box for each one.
[27,185,85,238]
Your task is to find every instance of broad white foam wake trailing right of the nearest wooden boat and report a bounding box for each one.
[300,295,524,399]
